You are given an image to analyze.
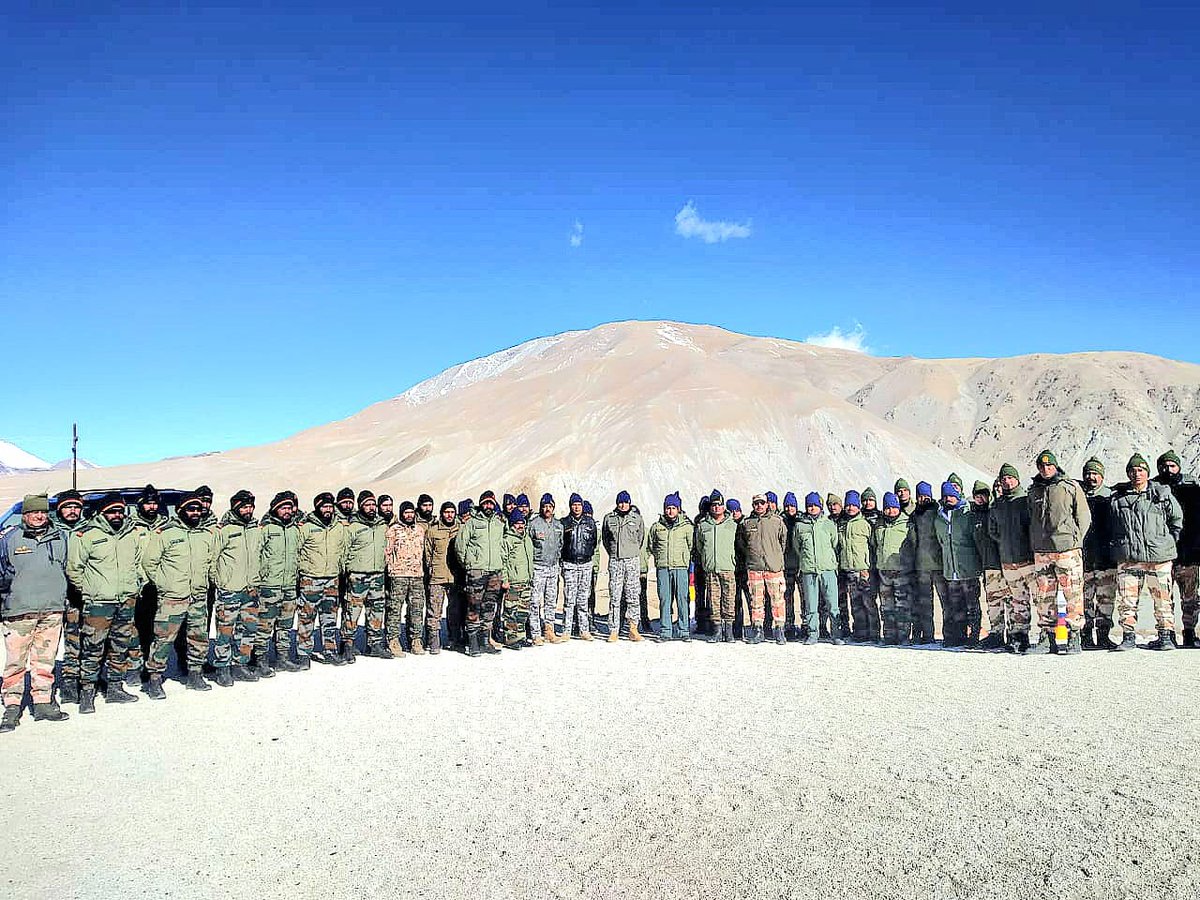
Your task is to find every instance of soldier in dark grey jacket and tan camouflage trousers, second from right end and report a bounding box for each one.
[1111,454,1183,650]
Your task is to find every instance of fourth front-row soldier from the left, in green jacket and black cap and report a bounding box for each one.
[212,490,263,688]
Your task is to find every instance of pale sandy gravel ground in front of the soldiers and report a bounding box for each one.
[0,641,1200,898]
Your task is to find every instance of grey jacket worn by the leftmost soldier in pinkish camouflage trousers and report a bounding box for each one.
[0,523,67,619]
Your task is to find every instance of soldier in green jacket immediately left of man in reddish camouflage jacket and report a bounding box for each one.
[342,491,392,662]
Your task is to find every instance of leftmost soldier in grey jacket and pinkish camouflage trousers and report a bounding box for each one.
[0,494,68,732]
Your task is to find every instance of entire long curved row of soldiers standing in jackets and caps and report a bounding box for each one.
[0,451,1198,730]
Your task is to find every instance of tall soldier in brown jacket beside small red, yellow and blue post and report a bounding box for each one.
[1030,450,1092,654]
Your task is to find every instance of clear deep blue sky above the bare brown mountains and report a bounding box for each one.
[0,0,1200,463]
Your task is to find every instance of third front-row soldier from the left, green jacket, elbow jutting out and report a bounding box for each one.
[142,492,216,700]
